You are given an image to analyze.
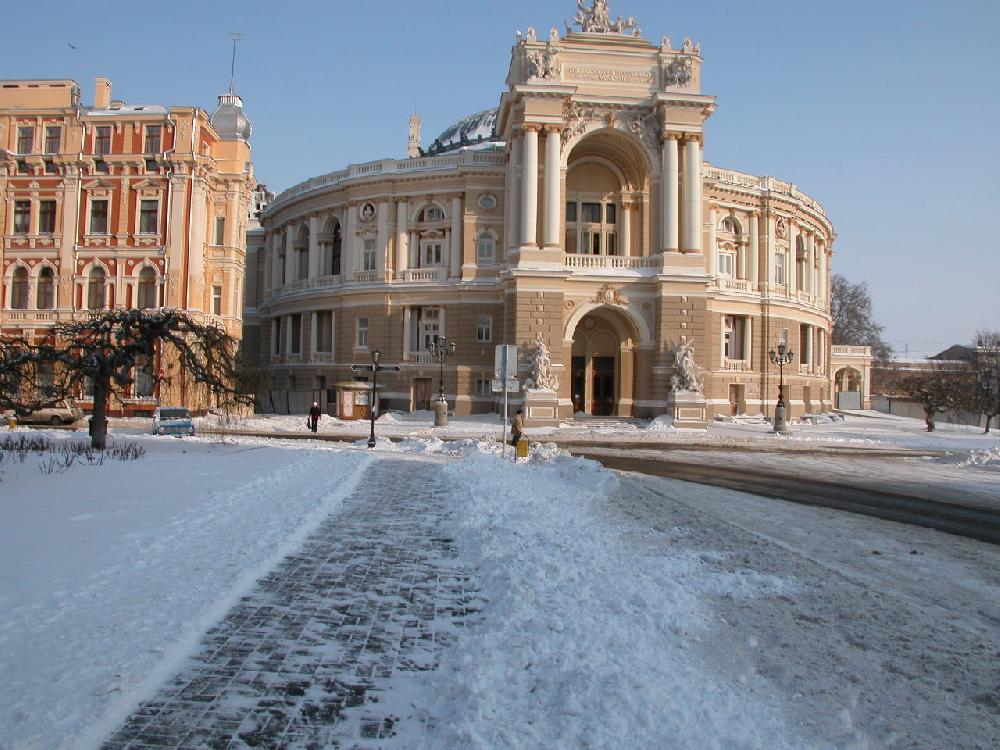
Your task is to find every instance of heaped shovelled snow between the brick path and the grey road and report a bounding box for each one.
[414,453,801,748]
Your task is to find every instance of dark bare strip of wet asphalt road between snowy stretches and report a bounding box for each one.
[566,446,1000,544]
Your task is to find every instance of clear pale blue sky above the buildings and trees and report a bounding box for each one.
[9,0,1000,354]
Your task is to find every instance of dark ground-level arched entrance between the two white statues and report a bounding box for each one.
[570,307,637,417]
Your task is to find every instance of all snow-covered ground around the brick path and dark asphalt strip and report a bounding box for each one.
[0,415,1000,750]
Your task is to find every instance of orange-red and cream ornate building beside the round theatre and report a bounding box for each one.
[0,78,254,414]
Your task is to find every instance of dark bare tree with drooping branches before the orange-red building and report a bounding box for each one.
[4,309,252,449]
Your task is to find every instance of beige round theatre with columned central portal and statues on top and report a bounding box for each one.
[247,3,834,417]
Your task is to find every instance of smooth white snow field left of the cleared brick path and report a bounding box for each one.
[0,438,368,748]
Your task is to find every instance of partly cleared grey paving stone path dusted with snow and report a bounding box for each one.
[103,459,478,750]
